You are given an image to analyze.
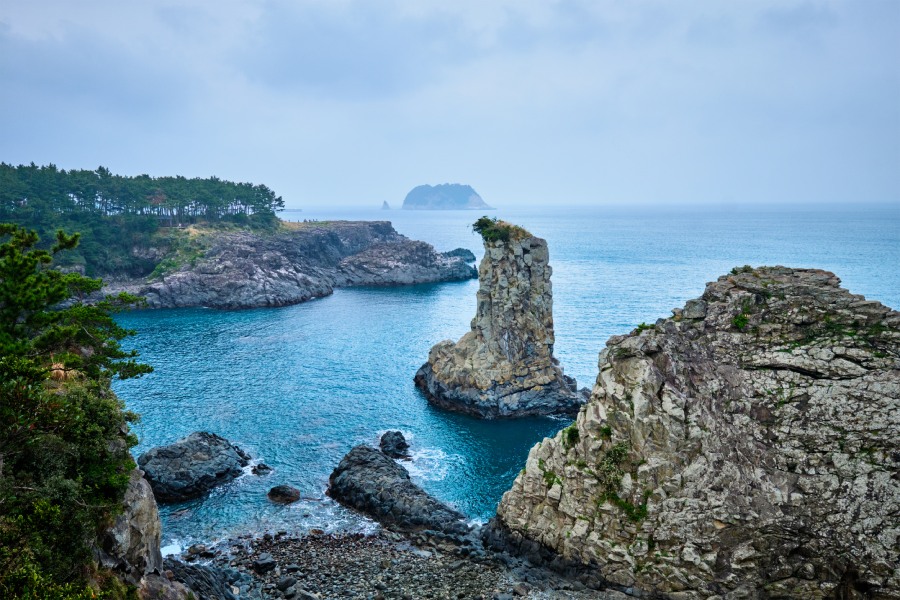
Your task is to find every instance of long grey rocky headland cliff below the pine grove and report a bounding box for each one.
[105,221,477,309]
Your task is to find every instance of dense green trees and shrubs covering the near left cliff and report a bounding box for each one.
[0,224,151,598]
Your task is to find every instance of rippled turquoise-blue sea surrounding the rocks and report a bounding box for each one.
[114,205,900,553]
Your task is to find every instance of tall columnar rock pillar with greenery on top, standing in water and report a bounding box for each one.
[415,217,586,419]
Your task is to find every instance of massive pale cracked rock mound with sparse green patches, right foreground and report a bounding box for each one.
[489,267,900,599]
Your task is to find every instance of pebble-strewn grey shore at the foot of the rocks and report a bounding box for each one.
[182,530,628,600]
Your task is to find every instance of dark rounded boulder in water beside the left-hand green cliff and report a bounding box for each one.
[137,431,250,502]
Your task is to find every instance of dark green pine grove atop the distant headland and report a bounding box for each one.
[0,163,284,276]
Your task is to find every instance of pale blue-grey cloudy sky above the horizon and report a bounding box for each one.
[0,0,900,208]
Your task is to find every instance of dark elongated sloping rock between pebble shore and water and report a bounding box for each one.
[327,446,468,535]
